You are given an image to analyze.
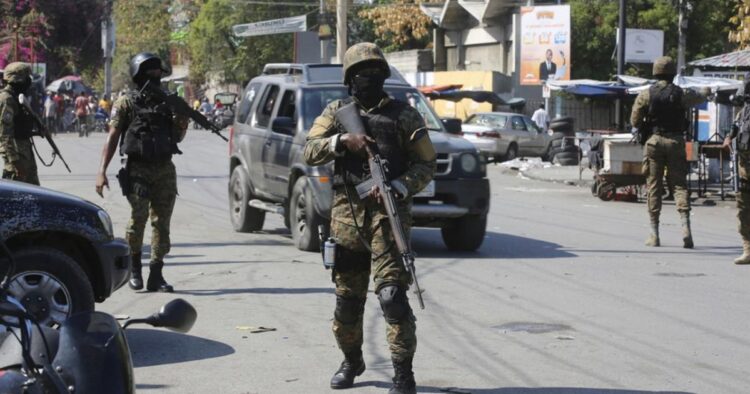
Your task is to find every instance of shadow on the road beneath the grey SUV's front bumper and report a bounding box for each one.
[411,228,577,259]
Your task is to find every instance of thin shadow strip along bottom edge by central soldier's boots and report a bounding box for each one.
[354,381,693,394]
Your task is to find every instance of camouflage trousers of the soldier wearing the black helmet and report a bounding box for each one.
[125,160,177,261]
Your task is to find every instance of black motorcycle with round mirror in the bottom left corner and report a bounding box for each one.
[0,242,197,394]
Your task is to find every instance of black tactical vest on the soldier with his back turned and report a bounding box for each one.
[648,83,688,134]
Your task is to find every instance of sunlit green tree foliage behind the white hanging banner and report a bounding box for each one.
[187,0,300,85]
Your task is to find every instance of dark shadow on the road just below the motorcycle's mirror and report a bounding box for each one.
[125,328,234,368]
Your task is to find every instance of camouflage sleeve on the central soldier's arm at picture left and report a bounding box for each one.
[304,102,339,166]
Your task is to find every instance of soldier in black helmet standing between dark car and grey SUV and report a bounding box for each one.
[96,52,188,292]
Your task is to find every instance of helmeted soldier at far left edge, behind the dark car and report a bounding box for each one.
[0,62,39,185]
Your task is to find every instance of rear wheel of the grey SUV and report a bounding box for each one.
[229,166,266,233]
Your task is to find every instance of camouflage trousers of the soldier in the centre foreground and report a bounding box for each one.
[331,188,417,360]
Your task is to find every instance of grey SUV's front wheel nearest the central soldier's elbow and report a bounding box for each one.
[289,176,323,252]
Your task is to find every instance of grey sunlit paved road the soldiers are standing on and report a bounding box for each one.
[32,131,750,394]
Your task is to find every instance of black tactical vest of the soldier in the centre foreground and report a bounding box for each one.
[333,100,408,186]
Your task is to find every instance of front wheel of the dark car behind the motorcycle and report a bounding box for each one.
[9,247,94,327]
